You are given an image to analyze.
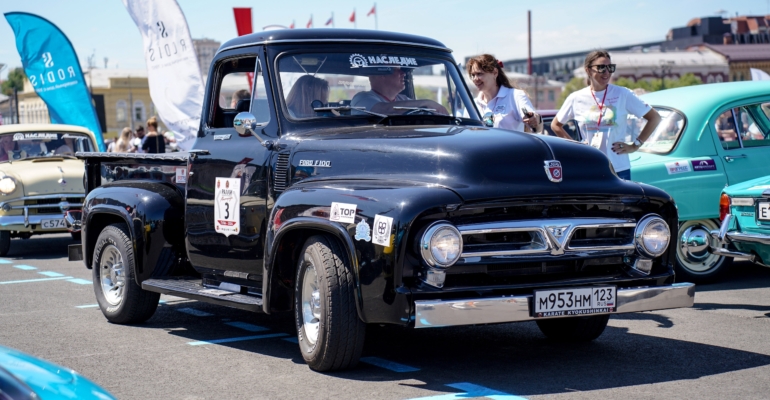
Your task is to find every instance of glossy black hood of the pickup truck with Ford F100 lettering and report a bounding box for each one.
[281,126,644,202]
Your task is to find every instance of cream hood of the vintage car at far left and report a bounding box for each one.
[0,157,85,196]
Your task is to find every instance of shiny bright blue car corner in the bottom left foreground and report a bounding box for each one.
[0,346,114,400]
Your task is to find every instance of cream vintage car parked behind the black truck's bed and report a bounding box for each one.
[0,124,96,256]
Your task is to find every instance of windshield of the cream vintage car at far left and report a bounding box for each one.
[0,132,94,162]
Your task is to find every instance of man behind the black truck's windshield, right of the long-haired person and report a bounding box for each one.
[350,67,449,115]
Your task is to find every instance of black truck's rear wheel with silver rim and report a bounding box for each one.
[92,224,160,324]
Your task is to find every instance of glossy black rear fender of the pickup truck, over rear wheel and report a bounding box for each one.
[82,181,184,284]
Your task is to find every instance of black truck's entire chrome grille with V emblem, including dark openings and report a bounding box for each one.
[457,218,636,258]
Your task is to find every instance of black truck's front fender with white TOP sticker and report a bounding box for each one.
[263,181,461,325]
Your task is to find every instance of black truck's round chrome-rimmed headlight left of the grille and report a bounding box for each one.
[420,221,463,268]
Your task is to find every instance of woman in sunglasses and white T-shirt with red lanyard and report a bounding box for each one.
[551,50,660,180]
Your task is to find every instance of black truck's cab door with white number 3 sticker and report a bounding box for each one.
[185,46,278,280]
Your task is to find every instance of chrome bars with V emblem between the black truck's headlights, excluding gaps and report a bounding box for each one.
[457,218,636,258]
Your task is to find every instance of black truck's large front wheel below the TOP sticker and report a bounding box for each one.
[294,235,366,371]
